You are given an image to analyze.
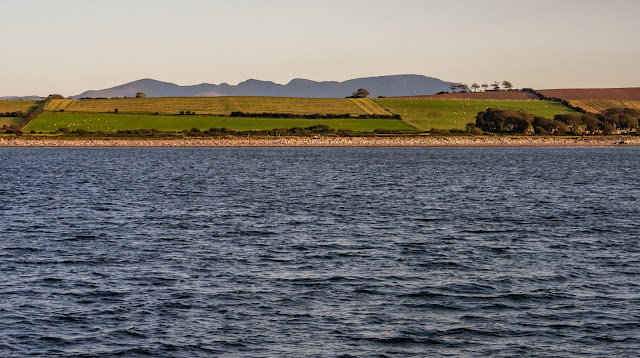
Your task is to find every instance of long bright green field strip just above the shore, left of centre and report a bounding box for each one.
[24,112,415,132]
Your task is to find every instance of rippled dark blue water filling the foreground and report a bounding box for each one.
[0,148,640,357]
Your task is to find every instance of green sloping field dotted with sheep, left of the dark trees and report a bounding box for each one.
[375,98,576,130]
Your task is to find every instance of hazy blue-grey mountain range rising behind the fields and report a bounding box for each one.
[72,75,451,98]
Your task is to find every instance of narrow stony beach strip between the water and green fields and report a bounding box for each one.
[0,136,640,147]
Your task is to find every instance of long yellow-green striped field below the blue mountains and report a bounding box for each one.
[45,97,388,115]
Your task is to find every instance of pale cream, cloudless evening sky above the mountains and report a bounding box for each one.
[0,0,640,96]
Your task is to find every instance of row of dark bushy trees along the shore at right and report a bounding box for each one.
[467,108,640,135]
